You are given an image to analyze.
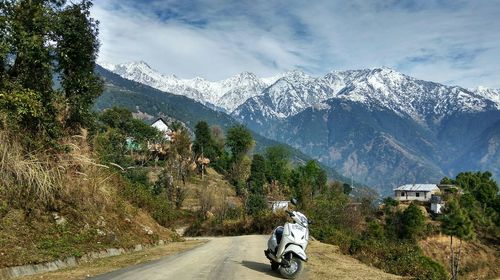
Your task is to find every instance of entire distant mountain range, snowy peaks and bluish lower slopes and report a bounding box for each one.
[99,62,500,194]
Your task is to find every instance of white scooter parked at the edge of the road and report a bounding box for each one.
[264,199,309,279]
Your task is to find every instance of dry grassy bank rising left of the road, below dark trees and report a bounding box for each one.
[0,131,178,268]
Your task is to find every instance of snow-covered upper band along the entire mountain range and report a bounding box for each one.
[102,61,500,121]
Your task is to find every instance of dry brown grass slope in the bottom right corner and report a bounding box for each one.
[419,235,500,279]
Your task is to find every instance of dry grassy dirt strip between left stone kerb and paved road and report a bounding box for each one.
[19,240,207,280]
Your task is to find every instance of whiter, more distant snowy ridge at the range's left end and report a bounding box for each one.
[101,61,280,112]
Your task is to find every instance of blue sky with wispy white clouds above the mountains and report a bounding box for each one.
[92,0,500,88]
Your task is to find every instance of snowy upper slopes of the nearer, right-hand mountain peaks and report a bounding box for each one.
[233,68,500,123]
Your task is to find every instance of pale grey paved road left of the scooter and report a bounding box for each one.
[91,235,296,280]
